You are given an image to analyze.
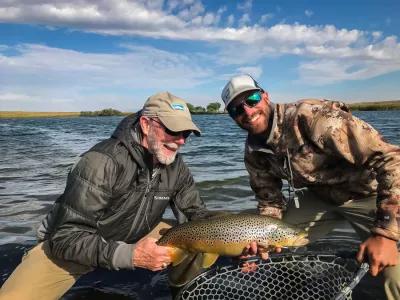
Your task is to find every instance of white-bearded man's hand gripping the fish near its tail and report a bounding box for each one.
[132,237,171,271]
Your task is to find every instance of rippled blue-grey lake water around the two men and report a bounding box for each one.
[0,111,400,299]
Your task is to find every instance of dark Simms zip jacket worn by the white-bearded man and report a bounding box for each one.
[39,112,208,270]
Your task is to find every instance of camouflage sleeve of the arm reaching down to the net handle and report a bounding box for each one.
[309,109,400,240]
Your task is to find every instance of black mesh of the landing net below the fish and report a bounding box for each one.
[178,254,368,300]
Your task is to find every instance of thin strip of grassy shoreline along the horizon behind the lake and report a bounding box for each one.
[0,100,400,119]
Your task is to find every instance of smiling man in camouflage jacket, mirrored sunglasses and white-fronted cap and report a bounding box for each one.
[221,75,400,299]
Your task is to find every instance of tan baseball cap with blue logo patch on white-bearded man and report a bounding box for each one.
[142,92,201,136]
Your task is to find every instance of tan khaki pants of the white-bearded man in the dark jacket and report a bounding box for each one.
[0,222,171,300]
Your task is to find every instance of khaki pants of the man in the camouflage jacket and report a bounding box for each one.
[283,192,400,300]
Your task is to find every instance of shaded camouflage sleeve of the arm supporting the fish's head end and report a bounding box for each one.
[244,151,286,218]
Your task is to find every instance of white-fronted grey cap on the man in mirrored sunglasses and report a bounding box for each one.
[221,75,262,107]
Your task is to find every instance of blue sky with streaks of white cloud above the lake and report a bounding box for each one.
[0,0,400,112]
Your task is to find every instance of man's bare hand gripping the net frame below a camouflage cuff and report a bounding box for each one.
[356,235,399,276]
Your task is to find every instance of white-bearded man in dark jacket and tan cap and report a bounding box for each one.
[0,92,211,300]
